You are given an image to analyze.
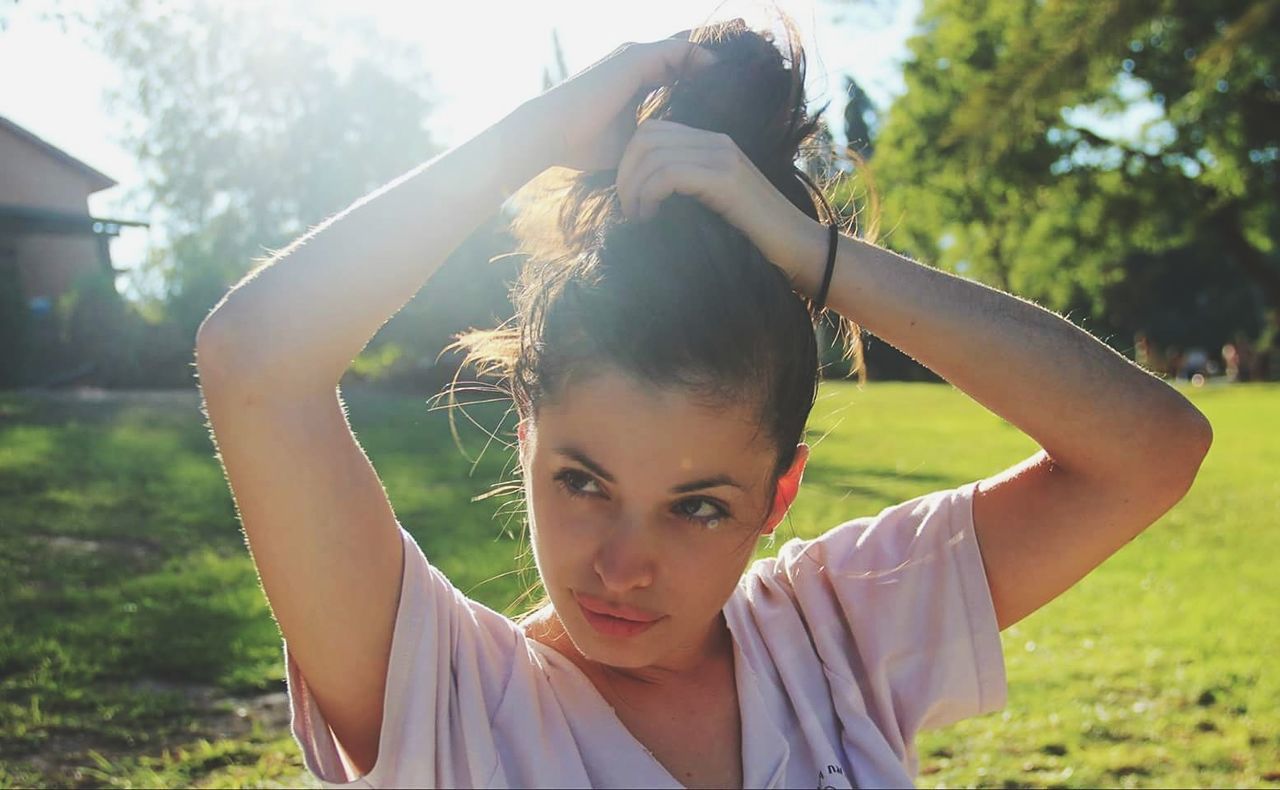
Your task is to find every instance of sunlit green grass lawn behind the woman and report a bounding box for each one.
[0,384,1280,787]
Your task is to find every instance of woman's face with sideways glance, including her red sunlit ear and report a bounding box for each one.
[521,373,808,668]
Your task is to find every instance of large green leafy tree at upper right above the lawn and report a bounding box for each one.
[873,0,1280,348]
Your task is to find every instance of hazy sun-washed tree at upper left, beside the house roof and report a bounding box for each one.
[95,0,439,338]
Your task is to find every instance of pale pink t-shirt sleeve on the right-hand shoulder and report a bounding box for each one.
[777,481,1006,754]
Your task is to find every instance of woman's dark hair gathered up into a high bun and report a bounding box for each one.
[457,18,860,478]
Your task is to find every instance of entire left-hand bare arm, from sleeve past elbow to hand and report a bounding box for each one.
[196,41,721,781]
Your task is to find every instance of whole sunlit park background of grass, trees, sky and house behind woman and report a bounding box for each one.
[0,0,1280,786]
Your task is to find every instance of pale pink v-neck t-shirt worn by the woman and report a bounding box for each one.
[284,483,1006,787]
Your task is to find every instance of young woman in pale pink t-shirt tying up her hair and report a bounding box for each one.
[197,15,1211,787]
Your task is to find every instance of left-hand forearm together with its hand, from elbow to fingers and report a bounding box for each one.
[197,31,714,381]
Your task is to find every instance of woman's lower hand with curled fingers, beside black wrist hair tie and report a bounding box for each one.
[617,118,826,283]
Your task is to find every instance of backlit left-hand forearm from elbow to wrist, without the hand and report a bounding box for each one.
[198,102,552,392]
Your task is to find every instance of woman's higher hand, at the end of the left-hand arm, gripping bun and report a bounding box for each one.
[530,31,716,170]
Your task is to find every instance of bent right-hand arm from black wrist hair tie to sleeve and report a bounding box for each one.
[776,225,1212,627]
